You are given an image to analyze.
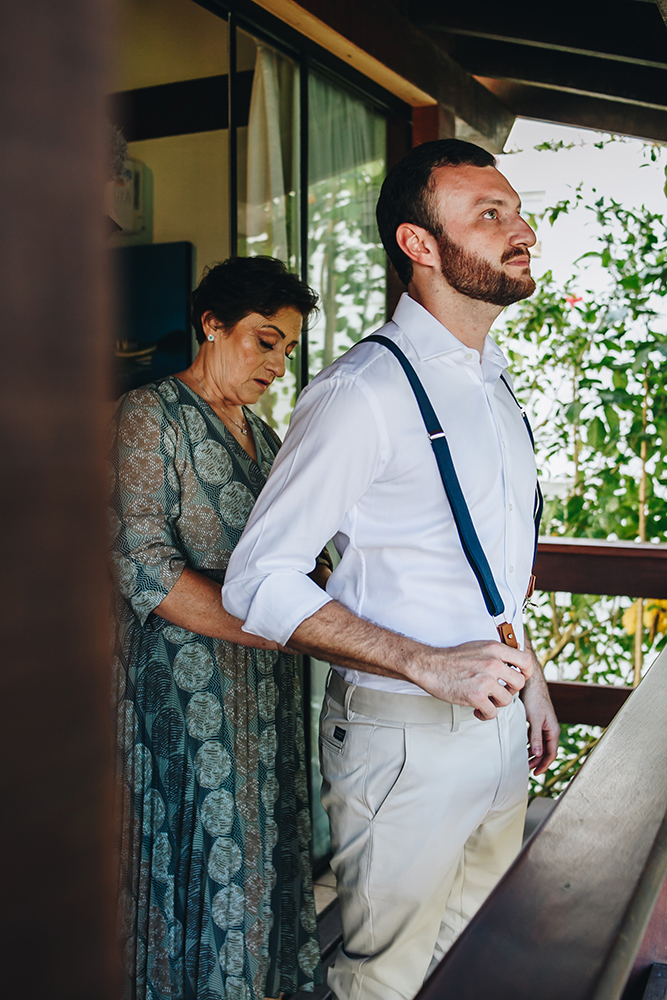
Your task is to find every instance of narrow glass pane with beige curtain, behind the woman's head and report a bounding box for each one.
[237,29,301,437]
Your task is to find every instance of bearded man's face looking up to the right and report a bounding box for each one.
[434,165,535,306]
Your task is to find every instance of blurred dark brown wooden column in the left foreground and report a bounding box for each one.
[0,0,115,1000]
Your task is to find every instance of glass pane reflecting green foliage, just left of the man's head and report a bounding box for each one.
[308,74,387,376]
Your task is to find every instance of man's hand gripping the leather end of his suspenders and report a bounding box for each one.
[406,639,533,719]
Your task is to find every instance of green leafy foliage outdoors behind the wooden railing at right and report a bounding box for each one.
[502,187,667,794]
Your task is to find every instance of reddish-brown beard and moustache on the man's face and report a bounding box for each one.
[437,230,535,306]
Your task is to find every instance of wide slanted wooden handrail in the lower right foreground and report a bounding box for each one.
[418,652,667,1000]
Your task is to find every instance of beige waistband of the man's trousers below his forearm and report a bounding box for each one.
[327,669,474,730]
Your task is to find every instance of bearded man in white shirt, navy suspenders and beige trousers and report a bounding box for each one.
[223,139,558,1000]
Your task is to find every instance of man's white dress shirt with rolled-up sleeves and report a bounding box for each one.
[222,294,536,694]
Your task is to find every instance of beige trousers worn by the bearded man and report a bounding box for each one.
[320,671,528,1000]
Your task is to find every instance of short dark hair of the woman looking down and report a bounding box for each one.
[191,257,317,344]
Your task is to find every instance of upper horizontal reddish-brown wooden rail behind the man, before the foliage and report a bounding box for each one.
[535,538,667,599]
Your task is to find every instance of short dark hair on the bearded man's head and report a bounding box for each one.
[377,139,496,285]
